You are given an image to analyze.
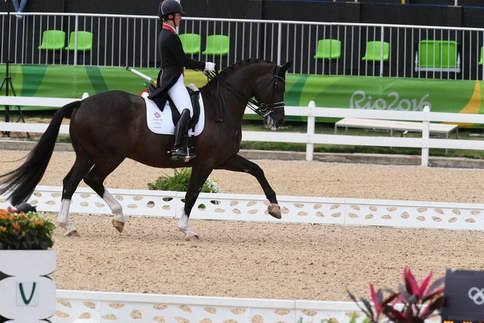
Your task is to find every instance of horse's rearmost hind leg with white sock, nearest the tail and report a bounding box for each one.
[57,154,94,236]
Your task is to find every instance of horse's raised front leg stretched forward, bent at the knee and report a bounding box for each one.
[217,155,281,219]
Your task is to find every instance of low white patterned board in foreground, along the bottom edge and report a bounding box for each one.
[52,290,366,323]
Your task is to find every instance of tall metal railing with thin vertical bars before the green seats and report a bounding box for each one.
[0,12,484,80]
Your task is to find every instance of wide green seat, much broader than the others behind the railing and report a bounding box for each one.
[415,40,460,72]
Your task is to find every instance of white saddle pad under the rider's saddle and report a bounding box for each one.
[141,92,205,137]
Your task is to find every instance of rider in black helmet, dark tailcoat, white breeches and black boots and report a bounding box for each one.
[149,0,215,160]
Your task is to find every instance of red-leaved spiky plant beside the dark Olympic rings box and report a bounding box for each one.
[348,268,444,323]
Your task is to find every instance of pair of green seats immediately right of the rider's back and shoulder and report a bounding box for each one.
[180,34,230,55]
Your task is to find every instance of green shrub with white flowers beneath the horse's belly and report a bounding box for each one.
[148,168,220,193]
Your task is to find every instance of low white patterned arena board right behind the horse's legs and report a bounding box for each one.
[0,186,484,231]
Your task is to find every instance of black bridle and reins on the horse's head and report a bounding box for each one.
[206,65,286,118]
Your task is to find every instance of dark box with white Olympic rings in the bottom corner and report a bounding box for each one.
[442,269,484,322]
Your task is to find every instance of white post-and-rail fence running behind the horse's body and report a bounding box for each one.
[0,93,484,166]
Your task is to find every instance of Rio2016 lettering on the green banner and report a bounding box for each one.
[350,90,432,111]
